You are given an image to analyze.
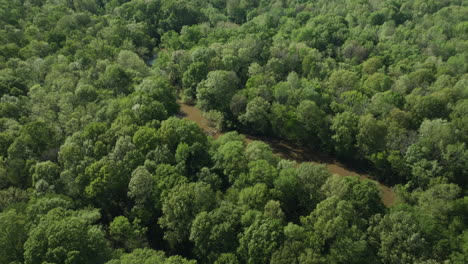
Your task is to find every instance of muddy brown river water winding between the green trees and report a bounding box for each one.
[179,102,395,207]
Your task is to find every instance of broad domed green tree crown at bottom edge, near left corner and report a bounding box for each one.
[24,208,110,264]
